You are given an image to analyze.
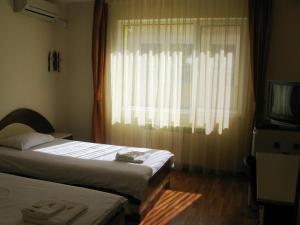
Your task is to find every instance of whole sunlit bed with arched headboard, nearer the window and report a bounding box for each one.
[0,109,173,221]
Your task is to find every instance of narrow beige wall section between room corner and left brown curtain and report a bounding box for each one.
[57,2,94,141]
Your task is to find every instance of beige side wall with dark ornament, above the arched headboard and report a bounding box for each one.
[0,0,65,125]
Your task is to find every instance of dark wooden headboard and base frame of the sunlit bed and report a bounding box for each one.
[0,108,173,223]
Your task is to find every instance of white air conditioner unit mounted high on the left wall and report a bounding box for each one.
[14,0,67,27]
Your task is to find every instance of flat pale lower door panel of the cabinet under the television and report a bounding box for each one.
[256,152,300,205]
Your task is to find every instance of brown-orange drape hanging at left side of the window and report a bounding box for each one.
[92,0,108,143]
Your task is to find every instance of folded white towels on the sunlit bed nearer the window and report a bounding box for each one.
[116,150,150,163]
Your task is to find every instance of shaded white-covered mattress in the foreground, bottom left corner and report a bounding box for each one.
[0,173,126,225]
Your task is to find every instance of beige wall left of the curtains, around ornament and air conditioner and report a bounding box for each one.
[0,0,93,140]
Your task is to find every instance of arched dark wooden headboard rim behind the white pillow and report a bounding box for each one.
[0,108,54,133]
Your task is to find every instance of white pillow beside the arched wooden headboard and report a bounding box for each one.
[0,132,54,150]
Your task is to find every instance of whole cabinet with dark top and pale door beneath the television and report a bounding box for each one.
[253,129,300,225]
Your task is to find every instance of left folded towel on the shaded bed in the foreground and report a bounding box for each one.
[21,200,65,219]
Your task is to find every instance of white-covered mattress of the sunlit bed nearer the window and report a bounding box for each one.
[0,139,173,200]
